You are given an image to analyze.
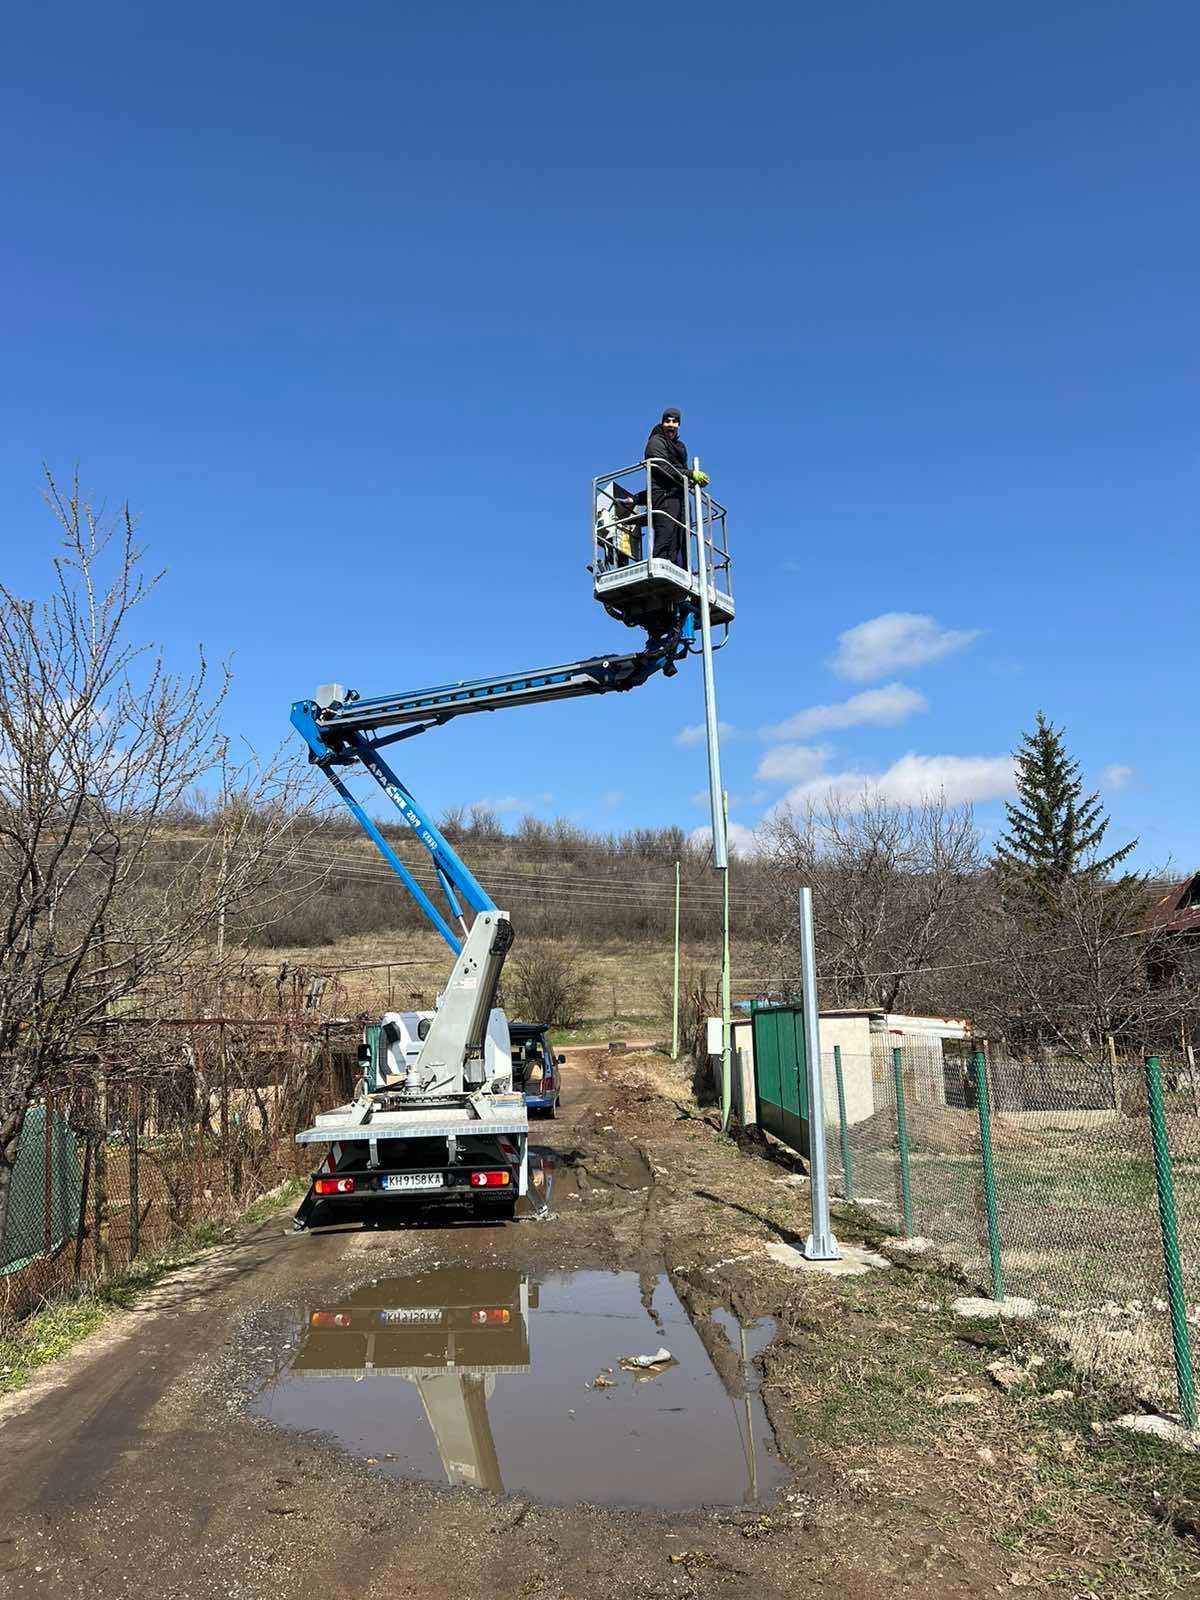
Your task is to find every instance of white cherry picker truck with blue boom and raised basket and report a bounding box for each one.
[291,461,733,1232]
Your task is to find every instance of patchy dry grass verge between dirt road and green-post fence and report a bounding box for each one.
[610,1056,1200,1600]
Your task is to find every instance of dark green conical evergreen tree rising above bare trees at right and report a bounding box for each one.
[995,712,1138,888]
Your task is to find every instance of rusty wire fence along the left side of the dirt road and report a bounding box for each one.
[0,1016,358,1323]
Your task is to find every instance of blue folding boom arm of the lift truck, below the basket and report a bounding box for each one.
[291,613,694,955]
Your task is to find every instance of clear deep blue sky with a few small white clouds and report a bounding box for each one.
[0,0,1200,870]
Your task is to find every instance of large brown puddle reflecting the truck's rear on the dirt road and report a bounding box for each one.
[250,1267,786,1510]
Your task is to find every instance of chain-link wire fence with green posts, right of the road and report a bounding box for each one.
[822,1035,1200,1416]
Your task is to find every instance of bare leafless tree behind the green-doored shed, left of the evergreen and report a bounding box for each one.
[760,792,982,1011]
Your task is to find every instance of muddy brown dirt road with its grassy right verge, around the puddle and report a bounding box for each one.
[0,1051,1200,1600]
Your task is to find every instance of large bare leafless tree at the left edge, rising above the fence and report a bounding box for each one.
[0,475,321,1235]
